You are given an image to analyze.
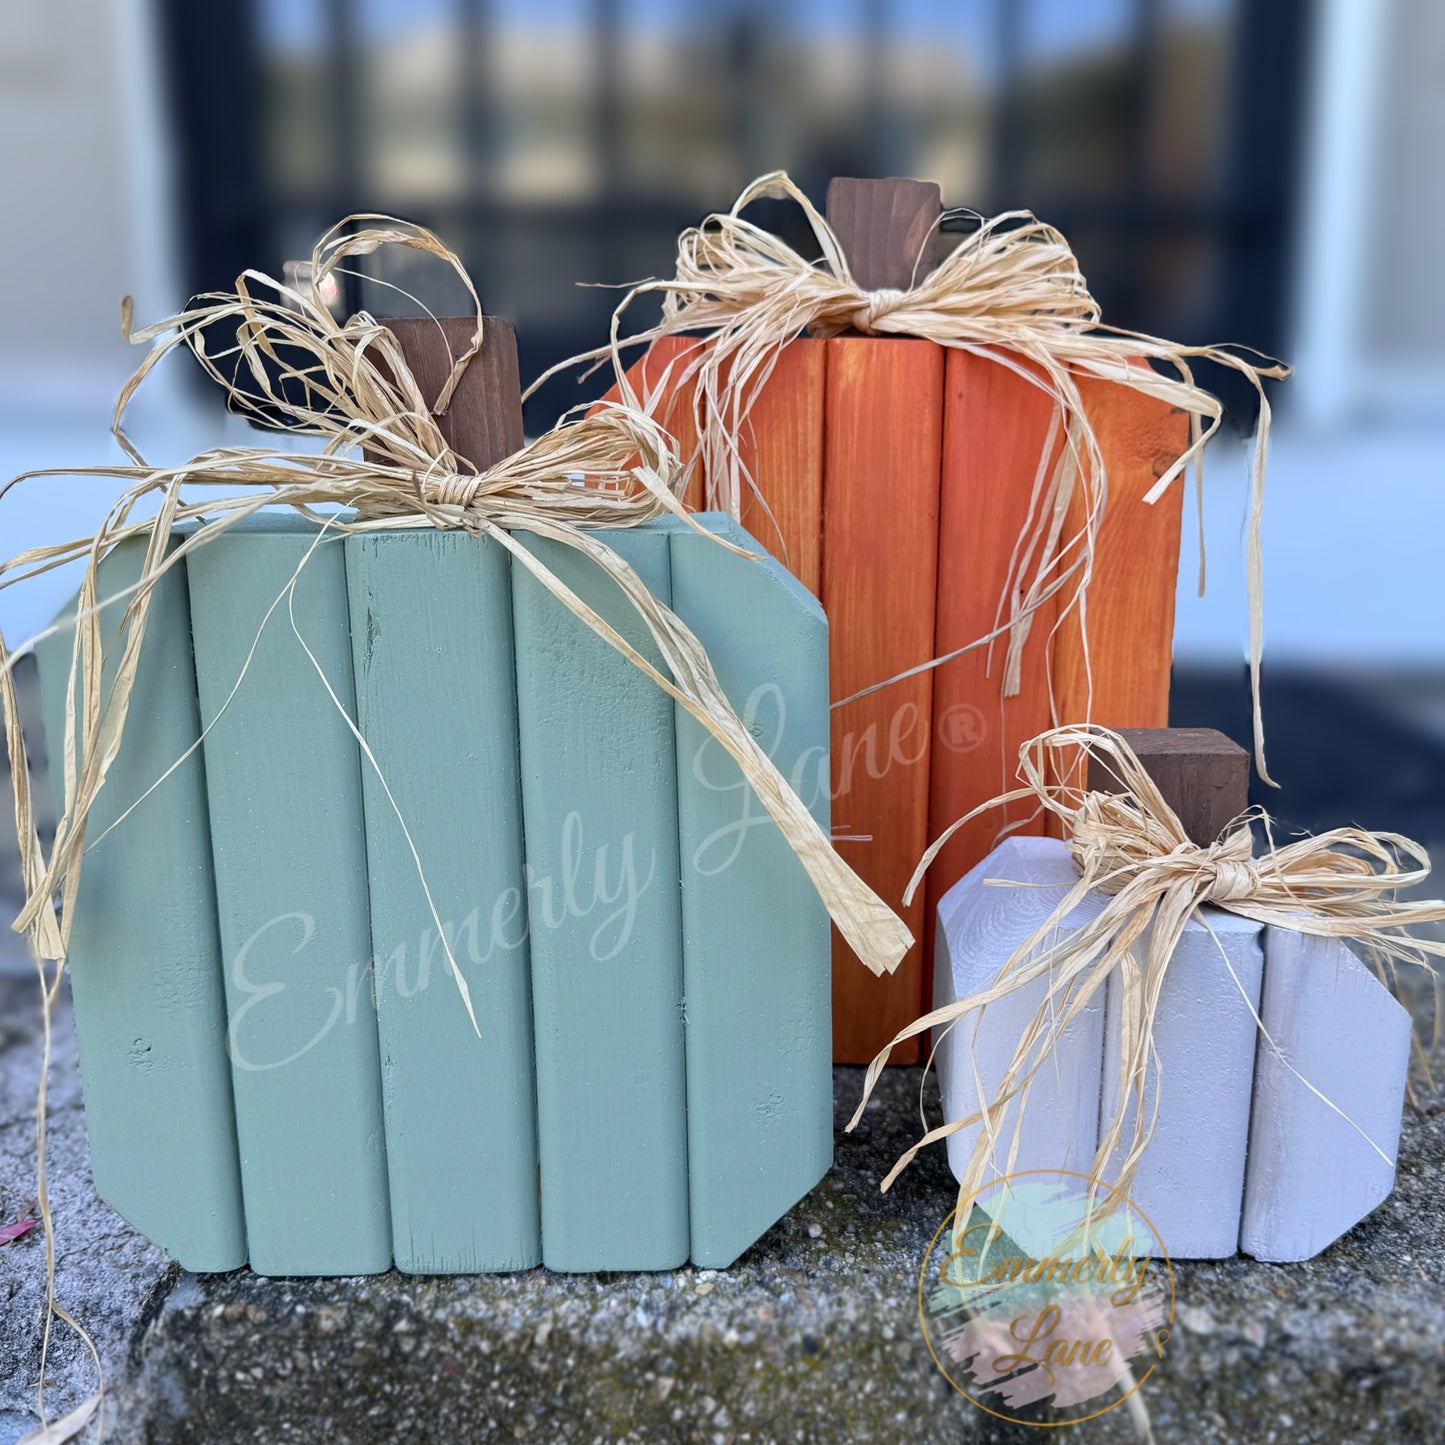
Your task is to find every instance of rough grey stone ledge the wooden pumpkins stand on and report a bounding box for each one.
[0,907,1445,1445]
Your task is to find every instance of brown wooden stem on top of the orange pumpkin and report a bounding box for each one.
[828,176,944,290]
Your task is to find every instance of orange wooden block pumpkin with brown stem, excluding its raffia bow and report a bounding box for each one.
[604,179,1189,1064]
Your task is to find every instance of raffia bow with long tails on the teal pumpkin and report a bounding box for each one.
[0,215,912,1416]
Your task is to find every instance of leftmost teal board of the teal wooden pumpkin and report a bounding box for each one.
[36,540,246,1272]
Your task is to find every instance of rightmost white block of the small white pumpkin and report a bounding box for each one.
[1240,928,1410,1263]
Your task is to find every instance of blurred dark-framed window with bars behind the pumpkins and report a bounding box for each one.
[163,0,1311,428]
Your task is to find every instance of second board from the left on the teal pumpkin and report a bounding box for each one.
[189,516,392,1274]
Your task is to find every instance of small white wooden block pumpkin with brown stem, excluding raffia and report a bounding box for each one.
[933,730,1410,1261]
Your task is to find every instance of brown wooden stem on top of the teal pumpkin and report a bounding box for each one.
[386,316,523,471]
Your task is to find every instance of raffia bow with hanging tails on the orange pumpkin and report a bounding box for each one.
[533,171,1289,780]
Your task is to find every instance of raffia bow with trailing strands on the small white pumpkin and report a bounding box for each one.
[848,725,1445,1236]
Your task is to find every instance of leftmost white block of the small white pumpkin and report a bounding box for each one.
[933,838,1104,1196]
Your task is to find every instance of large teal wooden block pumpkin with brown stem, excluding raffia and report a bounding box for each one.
[40,318,832,1274]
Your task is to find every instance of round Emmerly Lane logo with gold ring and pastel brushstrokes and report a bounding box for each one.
[918,1169,1175,1428]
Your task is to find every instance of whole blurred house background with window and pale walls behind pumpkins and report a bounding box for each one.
[0,0,1445,890]
